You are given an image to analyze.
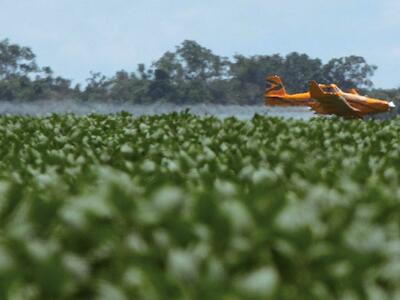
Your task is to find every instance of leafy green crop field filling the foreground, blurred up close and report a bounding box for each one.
[0,112,400,300]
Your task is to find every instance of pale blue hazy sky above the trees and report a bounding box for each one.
[0,0,400,88]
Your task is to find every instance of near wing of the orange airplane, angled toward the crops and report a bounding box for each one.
[310,81,360,115]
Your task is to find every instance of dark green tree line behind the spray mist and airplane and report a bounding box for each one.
[0,39,400,105]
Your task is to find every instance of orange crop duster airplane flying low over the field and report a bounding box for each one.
[265,75,395,118]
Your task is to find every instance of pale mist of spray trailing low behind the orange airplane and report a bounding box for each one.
[0,100,313,120]
